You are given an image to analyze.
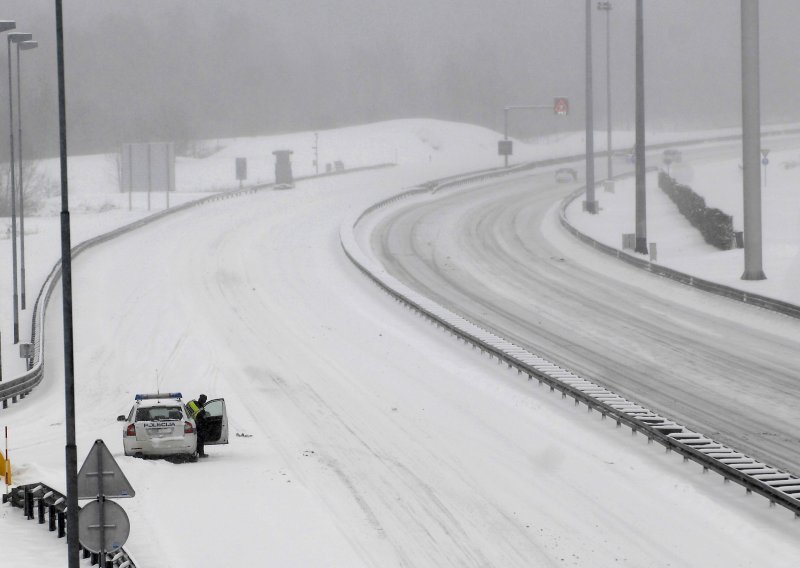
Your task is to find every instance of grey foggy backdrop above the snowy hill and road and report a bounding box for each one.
[0,0,800,156]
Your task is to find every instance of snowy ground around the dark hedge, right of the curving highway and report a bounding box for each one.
[568,136,800,304]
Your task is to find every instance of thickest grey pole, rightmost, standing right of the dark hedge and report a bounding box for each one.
[741,0,766,280]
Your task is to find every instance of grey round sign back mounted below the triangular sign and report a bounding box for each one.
[78,500,131,553]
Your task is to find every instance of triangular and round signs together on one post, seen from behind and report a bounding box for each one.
[78,440,136,566]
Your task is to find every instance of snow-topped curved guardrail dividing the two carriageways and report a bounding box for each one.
[346,143,800,518]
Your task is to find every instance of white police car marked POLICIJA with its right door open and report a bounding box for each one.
[117,392,228,460]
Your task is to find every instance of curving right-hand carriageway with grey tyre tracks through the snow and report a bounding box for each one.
[374,163,800,471]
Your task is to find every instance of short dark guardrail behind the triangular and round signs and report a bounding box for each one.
[3,483,136,568]
